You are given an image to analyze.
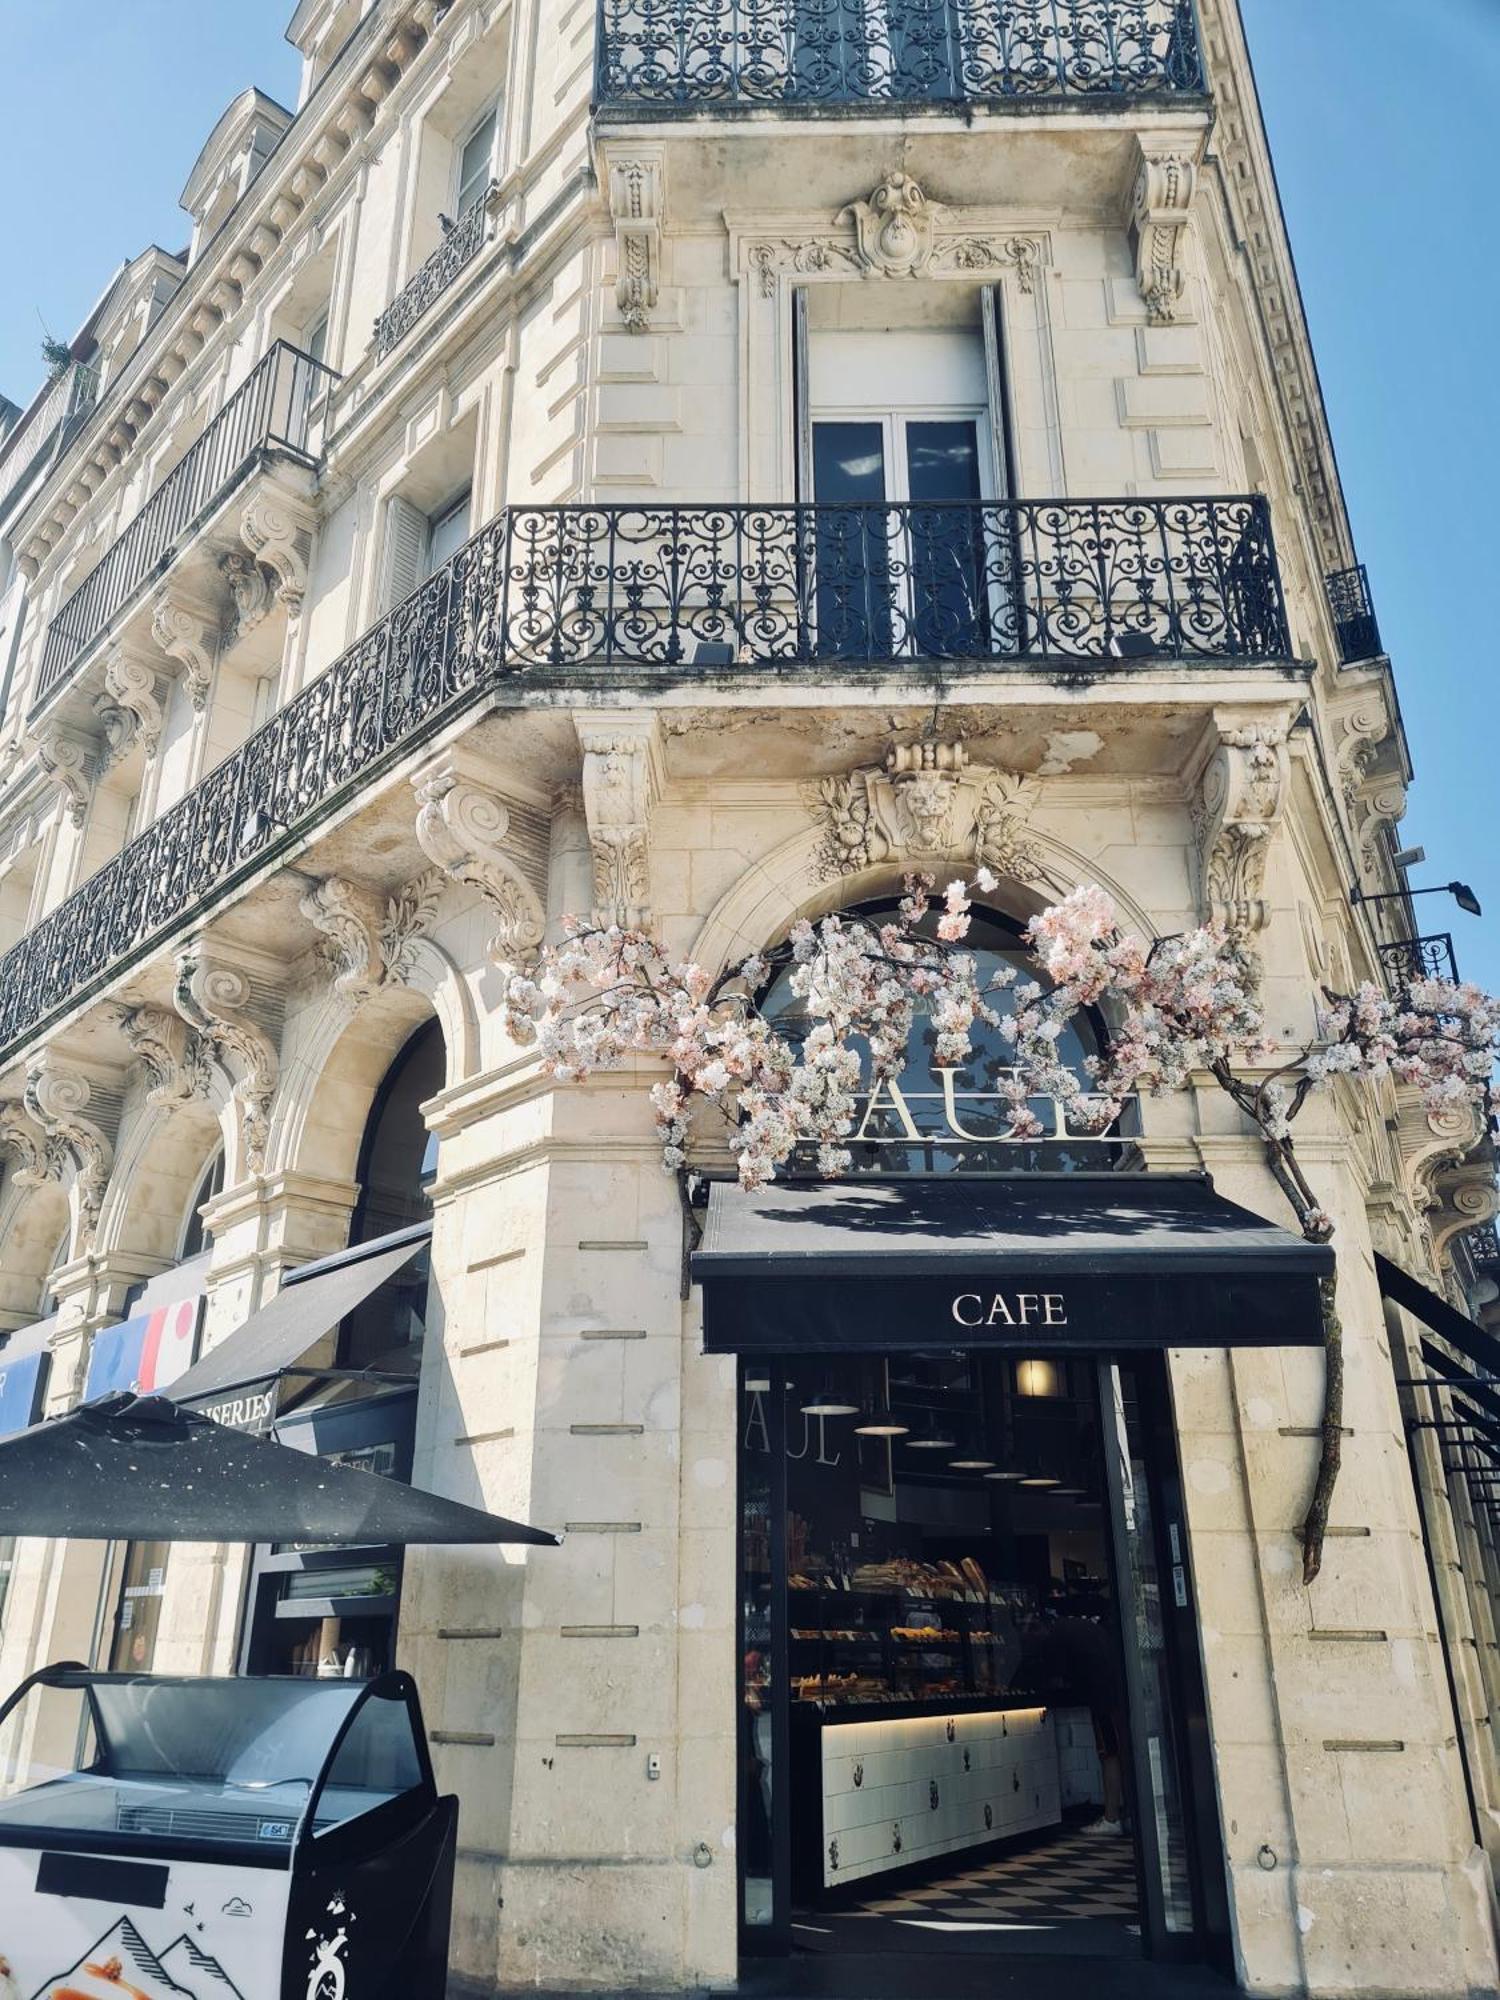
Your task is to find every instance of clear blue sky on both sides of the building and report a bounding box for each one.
[0,0,1500,988]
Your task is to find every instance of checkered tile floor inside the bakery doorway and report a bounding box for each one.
[846,1828,1138,1924]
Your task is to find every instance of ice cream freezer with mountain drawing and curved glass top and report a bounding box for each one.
[0,1666,458,2000]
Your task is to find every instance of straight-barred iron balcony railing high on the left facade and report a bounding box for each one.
[32,340,338,712]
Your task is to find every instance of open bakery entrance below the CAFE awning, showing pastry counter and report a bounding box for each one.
[738,1348,1228,1958]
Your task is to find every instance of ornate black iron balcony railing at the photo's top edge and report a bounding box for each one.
[596,0,1206,112]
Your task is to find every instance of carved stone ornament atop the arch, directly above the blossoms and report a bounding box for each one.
[806,740,1040,882]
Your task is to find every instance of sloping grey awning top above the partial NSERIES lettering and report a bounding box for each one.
[170,1222,432,1422]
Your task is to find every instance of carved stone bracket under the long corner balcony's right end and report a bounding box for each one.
[1194,720,1290,938]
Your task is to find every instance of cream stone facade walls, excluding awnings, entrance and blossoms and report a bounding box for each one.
[0,0,1500,1994]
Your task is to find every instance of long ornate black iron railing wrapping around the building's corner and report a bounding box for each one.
[0,496,1290,1062]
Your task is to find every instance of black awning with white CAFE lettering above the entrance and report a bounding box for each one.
[692,1174,1334,1354]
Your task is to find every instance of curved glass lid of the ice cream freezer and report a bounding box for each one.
[0,1668,432,1852]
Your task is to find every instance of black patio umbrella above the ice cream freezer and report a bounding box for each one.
[0,1392,556,1548]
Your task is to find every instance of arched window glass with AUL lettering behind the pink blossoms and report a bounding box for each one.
[760,902,1134,1176]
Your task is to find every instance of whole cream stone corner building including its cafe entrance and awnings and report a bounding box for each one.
[0,0,1500,1994]
